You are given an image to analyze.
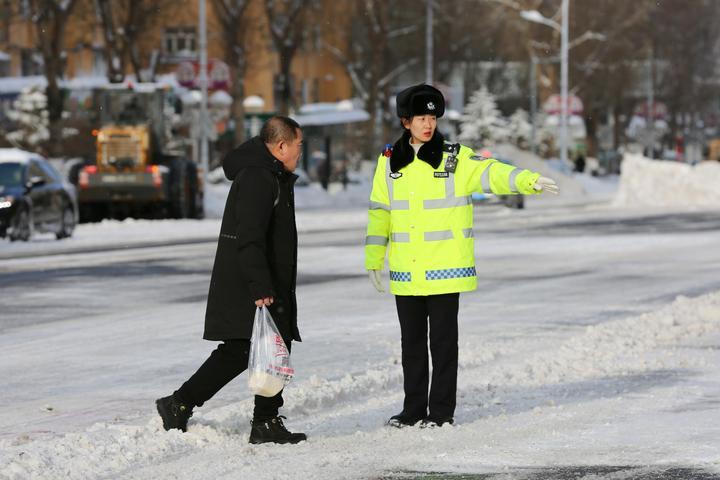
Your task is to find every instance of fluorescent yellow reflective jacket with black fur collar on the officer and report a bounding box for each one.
[365,132,540,295]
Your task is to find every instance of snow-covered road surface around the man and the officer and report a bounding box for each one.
[0,154,720,479]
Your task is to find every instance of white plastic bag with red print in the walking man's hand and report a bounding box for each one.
[248,307,295,397]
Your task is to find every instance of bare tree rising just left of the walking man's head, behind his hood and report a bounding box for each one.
[213,0,255,144]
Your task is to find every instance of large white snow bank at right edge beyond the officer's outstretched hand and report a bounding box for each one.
[614,154,720,208]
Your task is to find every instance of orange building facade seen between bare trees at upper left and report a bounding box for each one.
[0,0,352,112]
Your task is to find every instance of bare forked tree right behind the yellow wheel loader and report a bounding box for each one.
[95,0,172,83]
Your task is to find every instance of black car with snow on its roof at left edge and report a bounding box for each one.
[0,148,77,241]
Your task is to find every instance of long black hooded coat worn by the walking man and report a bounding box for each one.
[203,137,300,344]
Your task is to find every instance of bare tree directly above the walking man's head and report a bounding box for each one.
[265,0,311,115]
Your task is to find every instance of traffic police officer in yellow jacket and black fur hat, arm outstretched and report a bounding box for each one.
[365,84,558,427]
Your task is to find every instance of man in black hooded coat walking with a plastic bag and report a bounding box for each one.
[156,116,306,443]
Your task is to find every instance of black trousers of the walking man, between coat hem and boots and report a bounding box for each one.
[175,340,290,421]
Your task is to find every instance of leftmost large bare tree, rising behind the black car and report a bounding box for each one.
[28,0,77,155]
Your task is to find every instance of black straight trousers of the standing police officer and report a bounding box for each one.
[395,293,460,419]
